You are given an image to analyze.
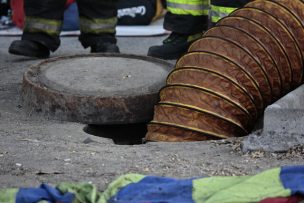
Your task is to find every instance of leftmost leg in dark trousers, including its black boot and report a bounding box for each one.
[9,0,65,57]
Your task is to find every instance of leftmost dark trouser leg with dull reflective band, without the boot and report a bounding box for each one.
[22,0,65,51]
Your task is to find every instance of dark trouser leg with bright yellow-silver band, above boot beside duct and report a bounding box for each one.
[164,0,209,34]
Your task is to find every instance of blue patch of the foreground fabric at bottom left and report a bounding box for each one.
[16,184,74,203]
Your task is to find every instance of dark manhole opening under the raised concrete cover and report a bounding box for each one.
[83,123,147,145]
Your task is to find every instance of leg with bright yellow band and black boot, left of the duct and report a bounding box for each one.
[148,0,209,59]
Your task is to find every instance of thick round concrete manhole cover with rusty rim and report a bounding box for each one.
[22,54,172,124]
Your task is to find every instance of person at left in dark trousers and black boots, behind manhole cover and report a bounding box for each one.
[9,0,119,58]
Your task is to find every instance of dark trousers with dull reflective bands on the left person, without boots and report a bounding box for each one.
[22,0,117,51]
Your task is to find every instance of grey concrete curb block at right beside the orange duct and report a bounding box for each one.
[242,85,304,152]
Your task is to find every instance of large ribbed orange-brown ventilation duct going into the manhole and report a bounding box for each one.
[146,0,304,141]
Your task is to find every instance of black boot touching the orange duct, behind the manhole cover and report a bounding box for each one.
[147,32,202,60]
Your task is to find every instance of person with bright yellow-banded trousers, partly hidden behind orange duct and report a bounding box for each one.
[148,0,250,60]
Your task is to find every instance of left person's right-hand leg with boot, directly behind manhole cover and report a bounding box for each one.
[77,0,119,52]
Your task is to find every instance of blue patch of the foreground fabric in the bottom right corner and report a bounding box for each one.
[280,166,304,195]
